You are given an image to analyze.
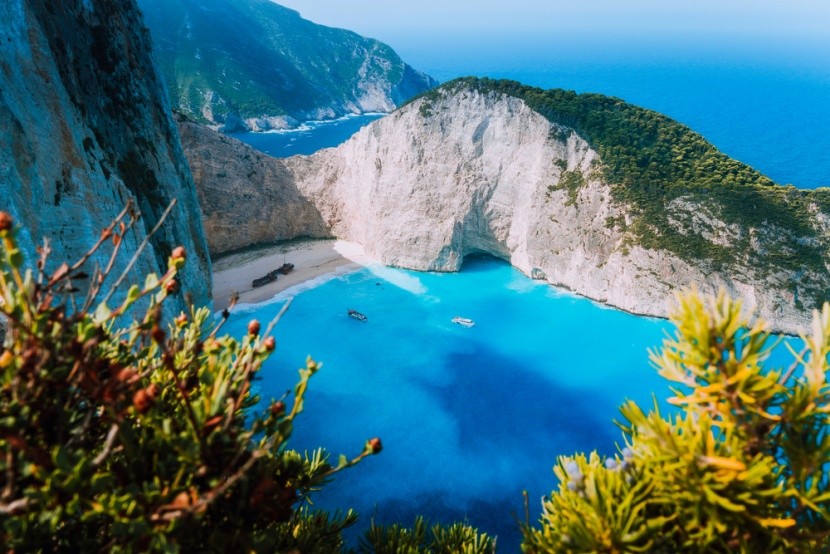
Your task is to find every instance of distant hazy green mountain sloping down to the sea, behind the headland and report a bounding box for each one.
[139,0,436,131]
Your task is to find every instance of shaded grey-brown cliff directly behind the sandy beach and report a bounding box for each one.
[177,115,331,252]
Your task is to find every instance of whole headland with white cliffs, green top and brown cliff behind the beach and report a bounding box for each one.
[185,80,830,333]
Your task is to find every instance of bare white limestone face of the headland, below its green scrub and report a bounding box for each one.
[285,86,827,332]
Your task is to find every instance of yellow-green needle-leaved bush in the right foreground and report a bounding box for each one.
[523,291,830,553]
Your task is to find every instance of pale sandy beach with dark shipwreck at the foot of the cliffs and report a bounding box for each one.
[213,239,370,310]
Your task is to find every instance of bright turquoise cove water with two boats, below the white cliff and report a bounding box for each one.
[228,258,800,552]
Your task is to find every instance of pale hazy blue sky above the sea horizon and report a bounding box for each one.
[278,0,830,43]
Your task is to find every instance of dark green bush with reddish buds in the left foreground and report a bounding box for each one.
[0,211,380,552]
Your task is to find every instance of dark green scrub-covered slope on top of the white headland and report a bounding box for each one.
[412,78,830,307]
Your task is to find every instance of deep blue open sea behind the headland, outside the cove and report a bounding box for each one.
[235,36,830,188]
